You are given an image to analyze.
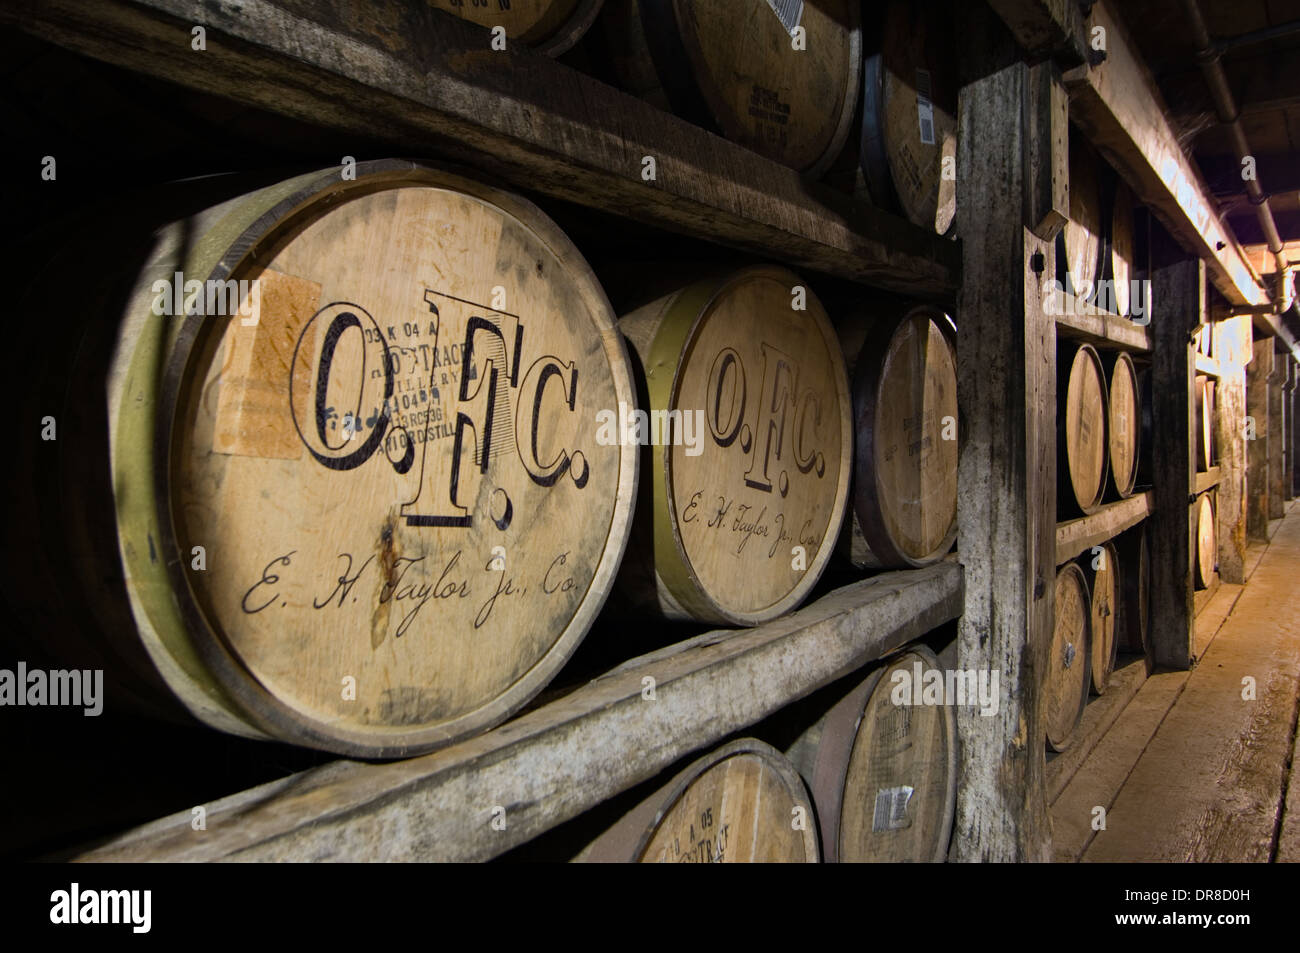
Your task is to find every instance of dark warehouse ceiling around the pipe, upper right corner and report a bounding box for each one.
[1113,0,1300,274]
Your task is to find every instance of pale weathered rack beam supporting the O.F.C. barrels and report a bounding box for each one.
[78,562,962,861]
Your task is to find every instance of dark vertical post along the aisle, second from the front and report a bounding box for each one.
[1147,259,1205,668]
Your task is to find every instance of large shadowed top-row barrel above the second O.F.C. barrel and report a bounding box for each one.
[601,0,862,178]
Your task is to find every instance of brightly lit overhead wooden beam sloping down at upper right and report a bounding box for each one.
[1065,1,1268,308]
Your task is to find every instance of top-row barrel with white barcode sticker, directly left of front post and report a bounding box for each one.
[861,0,959,234]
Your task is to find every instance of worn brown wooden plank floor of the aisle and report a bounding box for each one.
[1048,501,1300,862]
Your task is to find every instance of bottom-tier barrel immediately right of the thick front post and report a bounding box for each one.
[1047,563,1092,751]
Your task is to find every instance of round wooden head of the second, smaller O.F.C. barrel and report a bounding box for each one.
[670,274,848,612]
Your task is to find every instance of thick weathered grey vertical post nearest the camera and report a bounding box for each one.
[953,62,1067,861]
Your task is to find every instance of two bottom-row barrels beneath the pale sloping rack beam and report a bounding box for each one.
[576,645,956,863]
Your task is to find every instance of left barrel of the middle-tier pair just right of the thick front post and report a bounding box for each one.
[1057,341,1110,515]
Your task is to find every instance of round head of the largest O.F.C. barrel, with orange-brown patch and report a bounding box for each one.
[173,187,627,728]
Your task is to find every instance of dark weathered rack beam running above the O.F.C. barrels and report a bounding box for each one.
[0,0,961,298]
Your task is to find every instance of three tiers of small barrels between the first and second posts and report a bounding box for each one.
[1047,137,1151,751]
